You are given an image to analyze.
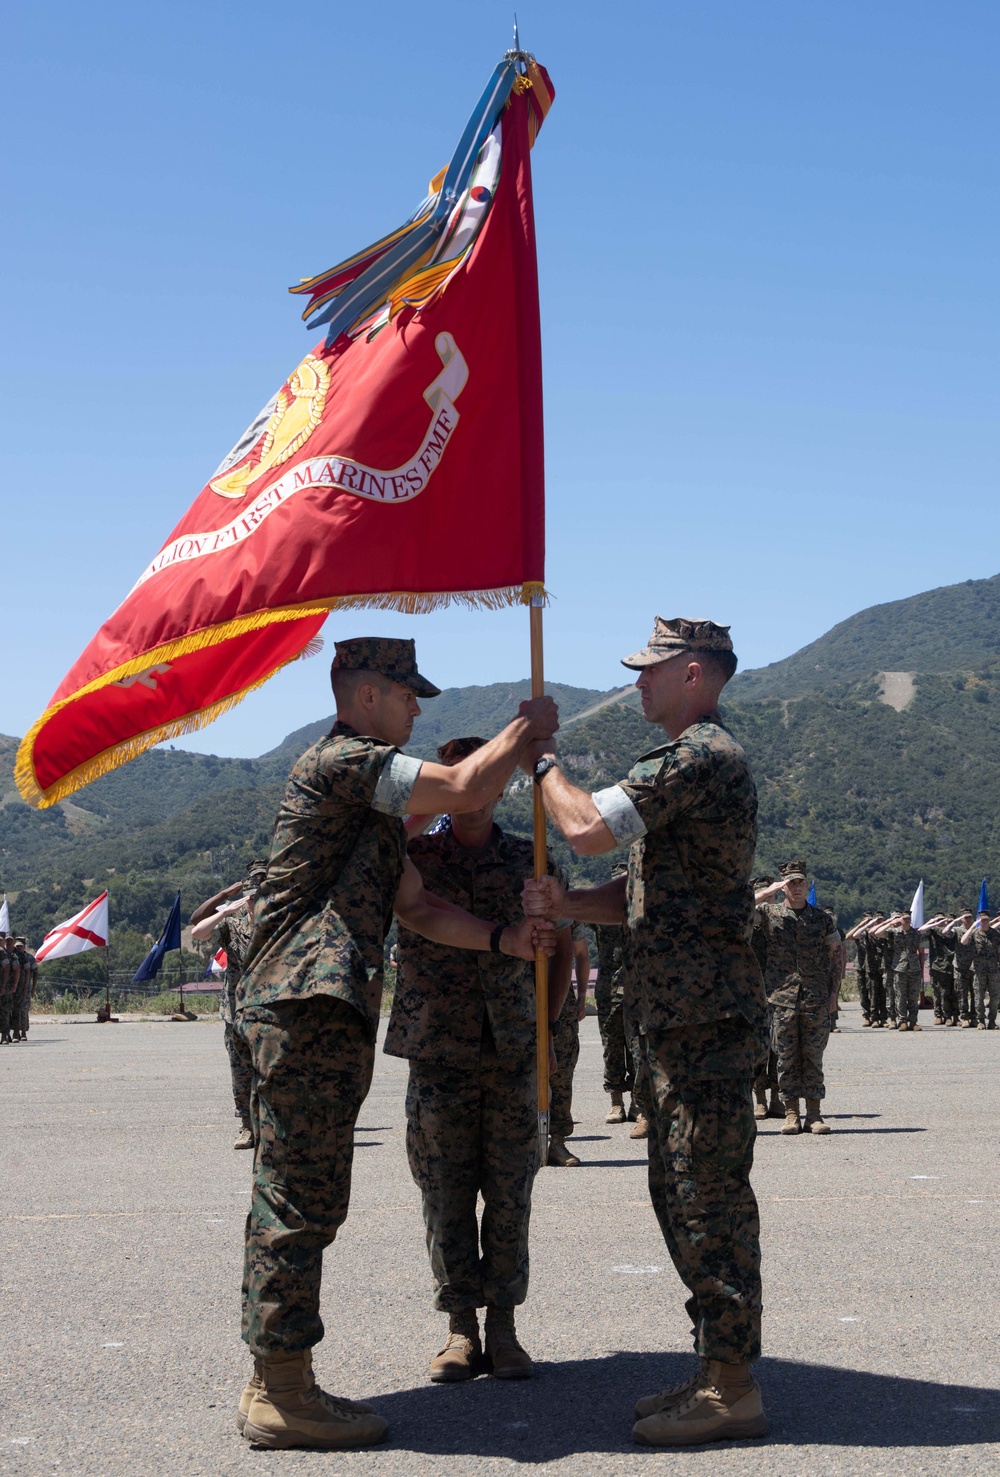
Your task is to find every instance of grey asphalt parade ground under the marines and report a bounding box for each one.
[0,1006,1000,1477]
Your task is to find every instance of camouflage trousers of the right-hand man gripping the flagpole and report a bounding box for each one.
[645,1021,761,1365]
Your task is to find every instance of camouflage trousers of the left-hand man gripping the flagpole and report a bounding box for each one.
[241,995,375,1357]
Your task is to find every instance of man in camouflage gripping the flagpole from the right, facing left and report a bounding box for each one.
[526,616,767,1446]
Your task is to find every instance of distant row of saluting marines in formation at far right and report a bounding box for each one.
[846,908,1000,1031]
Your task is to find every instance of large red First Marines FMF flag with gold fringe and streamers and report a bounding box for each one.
[16,62,552,806]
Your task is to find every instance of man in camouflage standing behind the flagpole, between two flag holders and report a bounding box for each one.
[384,740,572,1382]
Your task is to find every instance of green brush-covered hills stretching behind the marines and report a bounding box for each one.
[0,576,1000,973]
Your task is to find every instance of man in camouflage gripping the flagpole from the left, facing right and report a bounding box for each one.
[238,638,557,1449]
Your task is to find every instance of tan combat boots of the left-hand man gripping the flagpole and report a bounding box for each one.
[241,1349,388,1450]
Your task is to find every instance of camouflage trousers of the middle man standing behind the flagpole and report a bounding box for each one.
[406,1032,537,1313]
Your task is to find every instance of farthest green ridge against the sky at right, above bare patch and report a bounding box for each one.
[730,575,1000,702]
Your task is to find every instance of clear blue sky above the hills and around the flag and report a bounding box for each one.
[0,0,1000,755]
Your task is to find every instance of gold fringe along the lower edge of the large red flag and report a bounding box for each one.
[13,580,548,809]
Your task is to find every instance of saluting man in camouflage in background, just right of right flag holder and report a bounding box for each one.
[756,861,840,1134]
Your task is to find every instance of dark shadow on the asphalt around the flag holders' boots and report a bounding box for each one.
[366,1353,1000,1464]
